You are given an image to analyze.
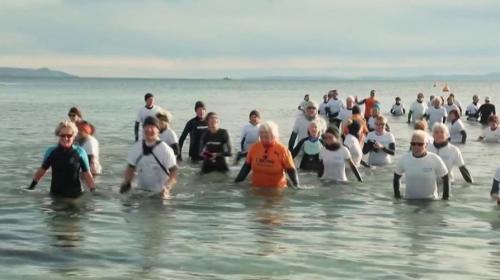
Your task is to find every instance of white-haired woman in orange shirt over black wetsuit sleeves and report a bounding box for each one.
[235,122,299,188]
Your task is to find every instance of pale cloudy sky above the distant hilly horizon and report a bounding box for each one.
[0,0,500,78]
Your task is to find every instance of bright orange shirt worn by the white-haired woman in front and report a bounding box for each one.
[246,142,295,188]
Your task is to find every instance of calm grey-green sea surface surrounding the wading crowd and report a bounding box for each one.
[0,79,500,279]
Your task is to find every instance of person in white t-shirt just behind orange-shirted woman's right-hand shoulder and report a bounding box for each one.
[288,101,326,151]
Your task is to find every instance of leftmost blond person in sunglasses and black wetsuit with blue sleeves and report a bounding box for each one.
[28,121,95,198]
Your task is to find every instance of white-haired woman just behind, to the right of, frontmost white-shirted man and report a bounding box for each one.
[428,123,472,183]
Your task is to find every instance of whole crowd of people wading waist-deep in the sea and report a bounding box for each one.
[29,90,500,204]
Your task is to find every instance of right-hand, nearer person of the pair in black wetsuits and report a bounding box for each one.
[200,112,231,173]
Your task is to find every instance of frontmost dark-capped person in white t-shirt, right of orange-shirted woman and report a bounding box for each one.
[318,127,363,182]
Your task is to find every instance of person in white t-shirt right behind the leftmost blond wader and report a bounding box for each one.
[76,121,102,176]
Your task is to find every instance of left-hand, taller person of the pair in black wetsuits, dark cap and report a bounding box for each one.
[177,101,208,162]
